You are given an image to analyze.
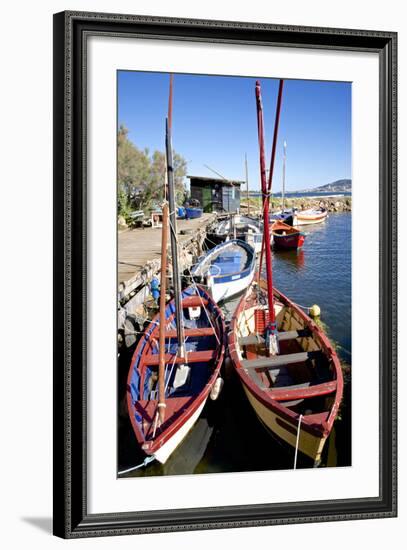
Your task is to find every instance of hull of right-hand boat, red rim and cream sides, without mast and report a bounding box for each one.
[229,281,343,464]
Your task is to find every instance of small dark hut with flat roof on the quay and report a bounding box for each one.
[187,176,244,212]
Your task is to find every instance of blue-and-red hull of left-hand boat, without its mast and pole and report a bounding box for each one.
[127,286,225,464]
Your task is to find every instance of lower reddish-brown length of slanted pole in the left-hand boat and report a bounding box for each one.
[158,202,168,424]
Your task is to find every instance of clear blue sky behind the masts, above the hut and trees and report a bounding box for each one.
[118,71,351,192]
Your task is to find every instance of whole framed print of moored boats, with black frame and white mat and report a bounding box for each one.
[54,12,397,538]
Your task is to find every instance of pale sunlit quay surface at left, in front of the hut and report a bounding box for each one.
[117,214,215,302]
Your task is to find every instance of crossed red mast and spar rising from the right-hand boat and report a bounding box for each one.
[256,80,284,355]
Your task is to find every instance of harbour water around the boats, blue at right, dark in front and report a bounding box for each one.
[118,213,352,476]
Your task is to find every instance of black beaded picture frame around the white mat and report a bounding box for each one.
[54,12,397,538]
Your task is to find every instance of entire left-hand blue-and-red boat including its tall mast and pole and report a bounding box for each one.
[127,76,225,464]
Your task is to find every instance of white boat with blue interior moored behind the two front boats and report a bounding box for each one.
[191,239,256,302]
